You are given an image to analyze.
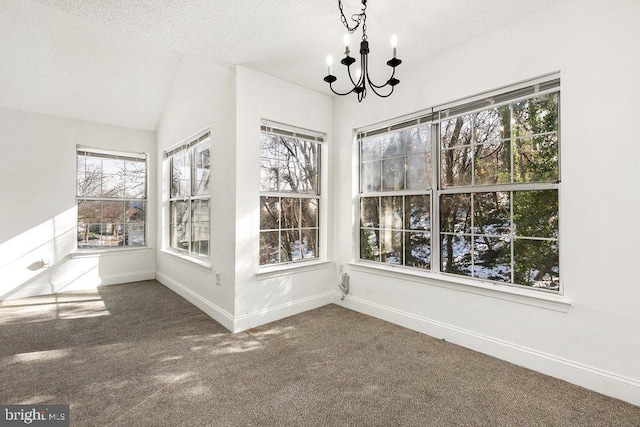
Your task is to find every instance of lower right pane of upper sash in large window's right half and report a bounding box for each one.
[513,133,558,182]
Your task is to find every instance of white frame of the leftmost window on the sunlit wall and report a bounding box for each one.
[75,145,149,252]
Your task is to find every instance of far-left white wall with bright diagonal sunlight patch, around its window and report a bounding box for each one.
[0,108,156,300]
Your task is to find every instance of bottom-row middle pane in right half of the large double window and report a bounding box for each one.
[473,236,511,282]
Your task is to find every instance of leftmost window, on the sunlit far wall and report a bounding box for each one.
[76,146,147,249]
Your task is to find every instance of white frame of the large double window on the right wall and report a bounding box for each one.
[354,73,564,296]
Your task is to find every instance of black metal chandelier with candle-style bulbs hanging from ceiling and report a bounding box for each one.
[324,0,402,102]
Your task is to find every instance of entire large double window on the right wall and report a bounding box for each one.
[359,79,560,291]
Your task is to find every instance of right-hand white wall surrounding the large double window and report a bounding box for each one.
[333,0,640,404]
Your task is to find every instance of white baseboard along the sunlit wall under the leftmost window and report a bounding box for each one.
[0,270,156,301]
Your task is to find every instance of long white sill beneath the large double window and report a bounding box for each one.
[349,262,571,313]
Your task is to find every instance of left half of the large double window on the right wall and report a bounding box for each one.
[360,124,432,269]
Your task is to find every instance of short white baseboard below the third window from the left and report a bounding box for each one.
[233,292,333,332]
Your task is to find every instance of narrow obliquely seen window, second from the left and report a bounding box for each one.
[166,131,211,258]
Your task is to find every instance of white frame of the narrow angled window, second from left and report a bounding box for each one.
[163,129,213,267]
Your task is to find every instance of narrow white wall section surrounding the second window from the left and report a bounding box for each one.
[156,57,236,330]
